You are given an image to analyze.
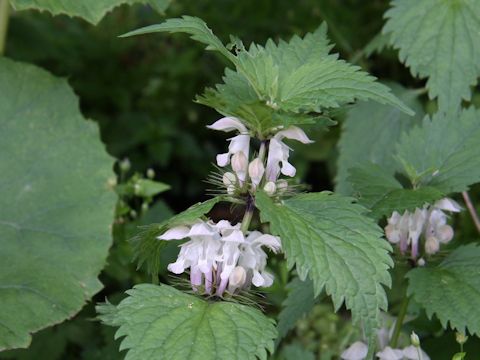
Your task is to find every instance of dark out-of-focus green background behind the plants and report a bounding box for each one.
[1,0,480,360]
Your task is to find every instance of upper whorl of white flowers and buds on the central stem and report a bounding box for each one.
[208,117,312,195]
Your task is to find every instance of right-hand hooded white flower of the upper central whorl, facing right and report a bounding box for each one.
[266,126,312,181]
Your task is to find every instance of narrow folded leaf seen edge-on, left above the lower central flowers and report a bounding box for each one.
[130,196,223,275]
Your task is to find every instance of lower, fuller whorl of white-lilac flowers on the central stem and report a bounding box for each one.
[159,220,281,296]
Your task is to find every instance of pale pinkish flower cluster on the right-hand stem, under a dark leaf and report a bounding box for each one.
[385,198,461,259]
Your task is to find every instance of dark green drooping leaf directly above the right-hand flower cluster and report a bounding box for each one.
[348,163,445,220]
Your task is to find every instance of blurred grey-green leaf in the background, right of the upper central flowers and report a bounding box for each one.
[336,83,424,195]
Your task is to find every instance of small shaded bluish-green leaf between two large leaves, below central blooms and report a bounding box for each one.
[277,277,316,341]
